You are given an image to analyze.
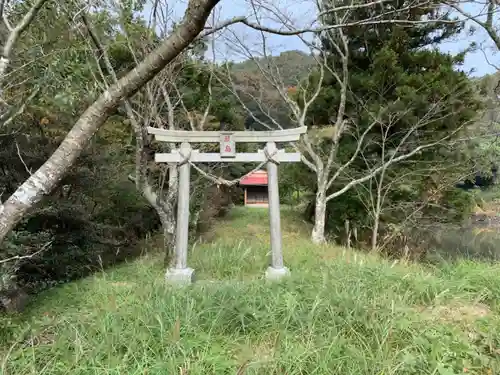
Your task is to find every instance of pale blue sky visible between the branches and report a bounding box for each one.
[145,0,500,76]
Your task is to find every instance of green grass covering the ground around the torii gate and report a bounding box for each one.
[0,208,500,375]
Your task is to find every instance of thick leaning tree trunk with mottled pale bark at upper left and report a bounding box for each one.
[0,0,220,243]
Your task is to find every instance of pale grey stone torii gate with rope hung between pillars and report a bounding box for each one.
[148,126,307,284]
